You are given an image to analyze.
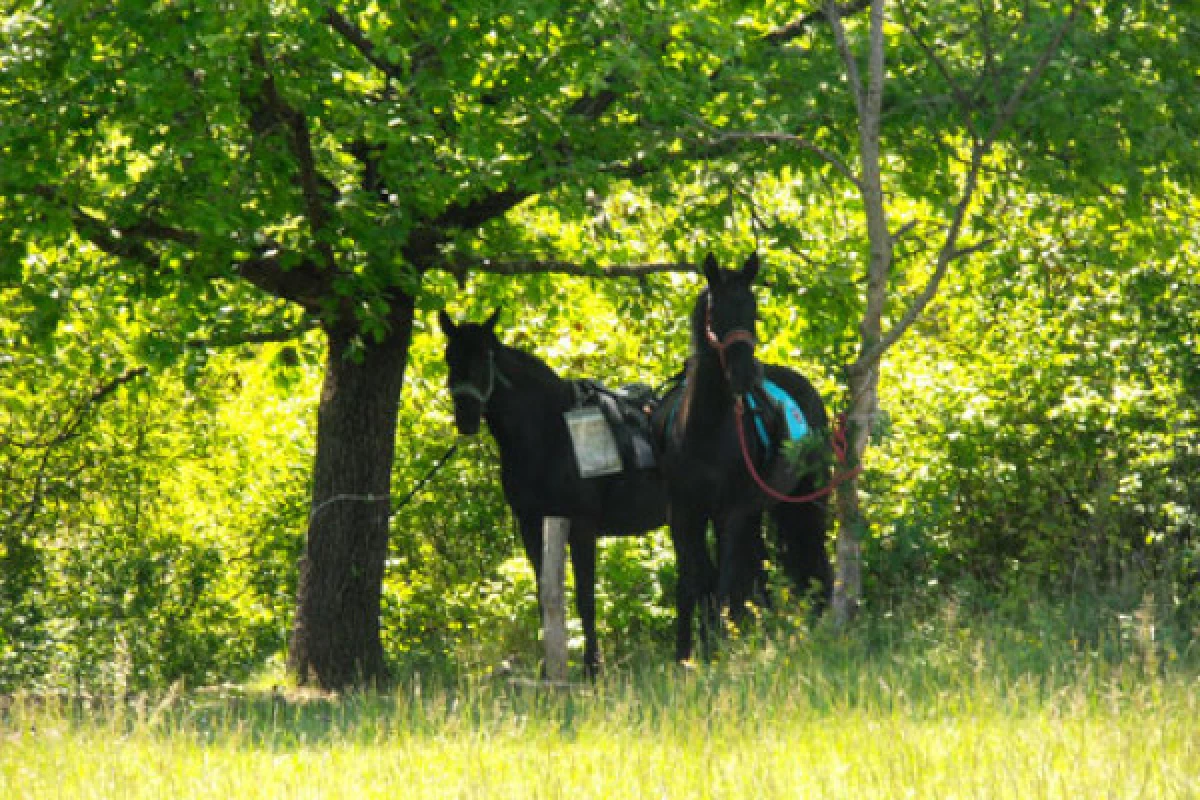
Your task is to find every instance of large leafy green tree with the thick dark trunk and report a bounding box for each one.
[0,0,734,686]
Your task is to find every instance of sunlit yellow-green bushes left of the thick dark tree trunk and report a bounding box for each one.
[0,271,314,692]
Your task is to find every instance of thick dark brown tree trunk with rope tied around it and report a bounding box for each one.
[288,296,413,688]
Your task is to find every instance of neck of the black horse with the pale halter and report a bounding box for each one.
[485,349,572,458]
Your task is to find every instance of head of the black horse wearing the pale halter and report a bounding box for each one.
[438,311,500,435]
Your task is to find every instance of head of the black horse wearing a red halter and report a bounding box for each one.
[696,253,762,397]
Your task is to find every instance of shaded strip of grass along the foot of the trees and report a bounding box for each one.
[0,587,1200,751]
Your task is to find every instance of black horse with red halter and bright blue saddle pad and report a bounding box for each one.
[655,254,833,660]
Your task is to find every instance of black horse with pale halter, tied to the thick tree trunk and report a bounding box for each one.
[438,312,666,675]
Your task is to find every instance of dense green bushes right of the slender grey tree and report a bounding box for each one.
[876,188,1200,626]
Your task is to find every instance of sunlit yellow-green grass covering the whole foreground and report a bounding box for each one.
[0,609,1200,800]
